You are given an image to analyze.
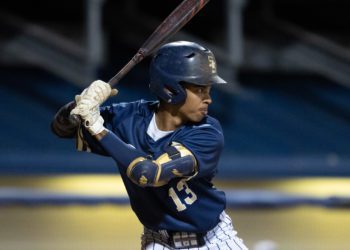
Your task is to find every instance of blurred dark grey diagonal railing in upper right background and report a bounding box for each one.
[245,17,350,87]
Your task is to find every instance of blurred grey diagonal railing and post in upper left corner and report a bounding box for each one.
[0,0,103,87]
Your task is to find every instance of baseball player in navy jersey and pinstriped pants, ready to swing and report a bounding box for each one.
[52,41,247,250]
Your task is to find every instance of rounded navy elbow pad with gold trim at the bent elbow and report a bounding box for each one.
[127,157,166,187]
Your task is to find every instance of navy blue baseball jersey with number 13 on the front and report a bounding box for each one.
[79,100,226,232]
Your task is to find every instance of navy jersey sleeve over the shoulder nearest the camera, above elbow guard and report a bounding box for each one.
[177,121,224,178]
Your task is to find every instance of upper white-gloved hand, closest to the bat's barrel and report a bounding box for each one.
[75,80,118,106]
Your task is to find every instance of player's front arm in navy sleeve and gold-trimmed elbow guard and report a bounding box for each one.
[95,130,197,187]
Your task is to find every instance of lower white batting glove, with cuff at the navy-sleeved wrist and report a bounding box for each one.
[70,99,105,135]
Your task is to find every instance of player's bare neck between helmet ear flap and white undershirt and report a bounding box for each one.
[156,103,185,131]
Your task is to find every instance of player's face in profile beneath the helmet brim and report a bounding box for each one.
[179,84,212,122]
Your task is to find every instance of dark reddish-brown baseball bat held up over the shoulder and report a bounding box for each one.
[108,0,209,86]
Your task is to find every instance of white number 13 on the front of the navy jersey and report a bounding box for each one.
[169,180,197,212]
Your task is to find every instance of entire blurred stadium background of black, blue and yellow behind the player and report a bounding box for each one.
[0,0,350,250]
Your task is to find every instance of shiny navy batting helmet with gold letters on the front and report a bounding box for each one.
[150,41,226,104]
